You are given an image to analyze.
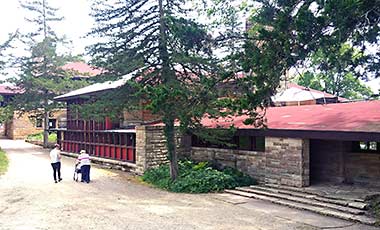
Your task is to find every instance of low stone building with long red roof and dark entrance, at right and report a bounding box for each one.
[191,101,380,187]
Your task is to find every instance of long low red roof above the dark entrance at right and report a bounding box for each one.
[202,101,380,132]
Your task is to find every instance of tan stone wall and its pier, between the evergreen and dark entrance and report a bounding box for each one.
[191,137,309,187]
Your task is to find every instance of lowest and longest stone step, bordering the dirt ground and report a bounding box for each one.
[225,189,376,225]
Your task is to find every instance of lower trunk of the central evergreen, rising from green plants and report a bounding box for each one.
[164,119,178,181]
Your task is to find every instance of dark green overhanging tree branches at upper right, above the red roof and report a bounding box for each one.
[223,0,380,111]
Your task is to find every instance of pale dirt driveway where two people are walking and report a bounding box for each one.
[0,140,374,230]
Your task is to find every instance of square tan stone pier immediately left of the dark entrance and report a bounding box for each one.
[265,137,310,187]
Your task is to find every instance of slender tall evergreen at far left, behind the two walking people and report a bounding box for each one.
[9,0,87,147]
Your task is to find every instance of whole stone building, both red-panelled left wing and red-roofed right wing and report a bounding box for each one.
[52,71,380,187]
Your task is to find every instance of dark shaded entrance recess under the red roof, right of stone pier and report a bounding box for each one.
[310,140,380,186]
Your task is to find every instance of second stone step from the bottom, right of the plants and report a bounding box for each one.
[236,187,365,215]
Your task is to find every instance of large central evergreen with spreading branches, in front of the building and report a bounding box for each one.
[90,0,229,179]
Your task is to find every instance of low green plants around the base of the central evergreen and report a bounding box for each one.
[142,161,256,193]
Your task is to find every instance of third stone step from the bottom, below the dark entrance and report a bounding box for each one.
[250,185,368,210]
